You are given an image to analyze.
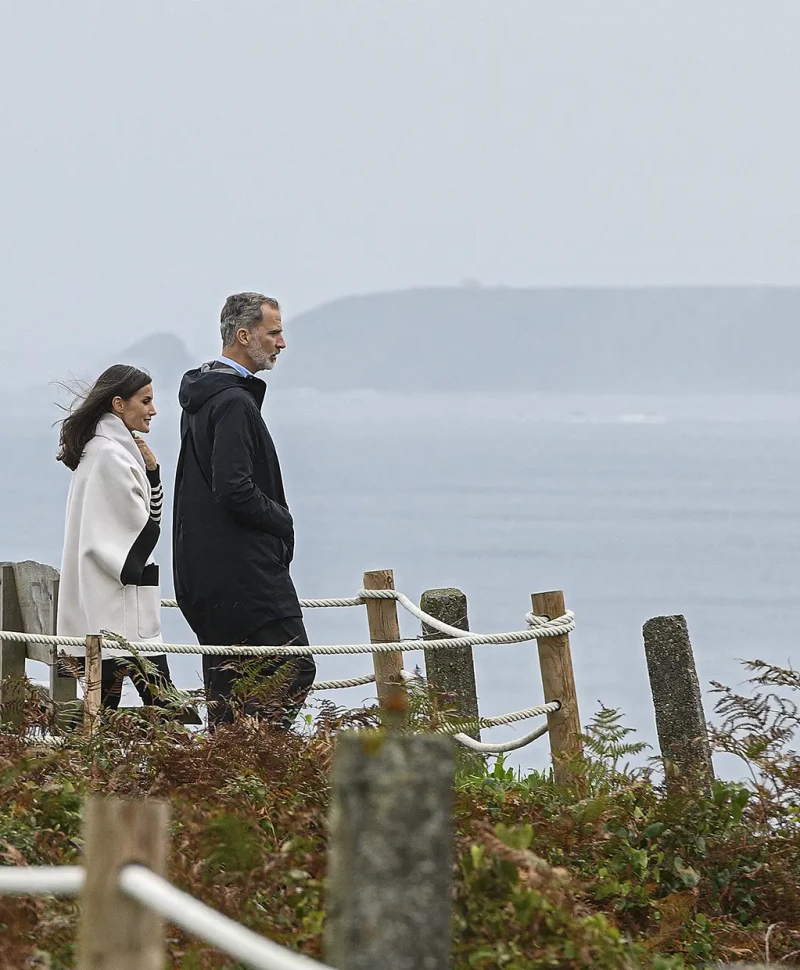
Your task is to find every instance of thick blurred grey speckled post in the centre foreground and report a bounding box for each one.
[325,733,455,970]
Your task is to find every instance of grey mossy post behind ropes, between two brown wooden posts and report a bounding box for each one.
[419,588,481,741]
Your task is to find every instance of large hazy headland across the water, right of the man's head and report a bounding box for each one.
[280,287,800,393]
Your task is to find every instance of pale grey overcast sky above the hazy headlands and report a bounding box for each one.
[0,0,800,381]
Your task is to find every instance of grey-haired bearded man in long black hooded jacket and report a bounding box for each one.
[173,293,316,728]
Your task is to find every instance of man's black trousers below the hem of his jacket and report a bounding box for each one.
[201,616,317,730]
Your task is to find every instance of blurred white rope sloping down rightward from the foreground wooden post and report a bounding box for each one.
[119,865,332,970]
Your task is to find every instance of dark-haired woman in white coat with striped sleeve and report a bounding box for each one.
[57,364,177,709]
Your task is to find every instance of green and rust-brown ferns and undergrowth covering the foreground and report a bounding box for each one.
[0,663,800,970]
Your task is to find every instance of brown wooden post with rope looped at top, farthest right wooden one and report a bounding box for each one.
[531,590,584,790]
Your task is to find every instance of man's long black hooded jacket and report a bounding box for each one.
[173,363,302,644]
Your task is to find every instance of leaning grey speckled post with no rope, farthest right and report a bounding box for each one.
[642,615,714,792]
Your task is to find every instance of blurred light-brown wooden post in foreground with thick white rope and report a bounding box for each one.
[76,797,169,970]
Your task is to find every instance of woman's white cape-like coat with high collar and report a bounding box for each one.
[57,414,161,657]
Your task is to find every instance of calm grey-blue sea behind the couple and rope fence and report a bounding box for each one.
[6,393,800,770]
